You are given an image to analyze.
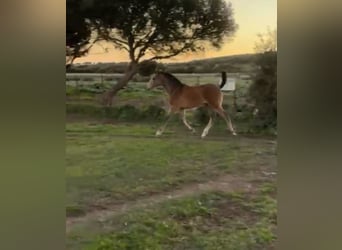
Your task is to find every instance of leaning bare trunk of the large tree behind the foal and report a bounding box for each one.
[102,62,138,106]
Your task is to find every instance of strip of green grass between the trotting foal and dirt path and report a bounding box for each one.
[66,123,271,214]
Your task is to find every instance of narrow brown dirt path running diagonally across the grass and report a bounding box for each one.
[66,173,275,233]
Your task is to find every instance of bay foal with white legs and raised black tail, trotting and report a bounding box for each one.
[147,72,236,138]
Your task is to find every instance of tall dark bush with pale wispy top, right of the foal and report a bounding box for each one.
[249,29,277,127]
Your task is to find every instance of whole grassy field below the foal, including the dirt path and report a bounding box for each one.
[66,121,276,249]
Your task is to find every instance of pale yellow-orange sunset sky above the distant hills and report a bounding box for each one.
[75,0,277,63]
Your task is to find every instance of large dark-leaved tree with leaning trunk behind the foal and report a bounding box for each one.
[92,0,237,105]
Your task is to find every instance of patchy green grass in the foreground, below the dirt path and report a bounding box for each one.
[67,188,277,250]
